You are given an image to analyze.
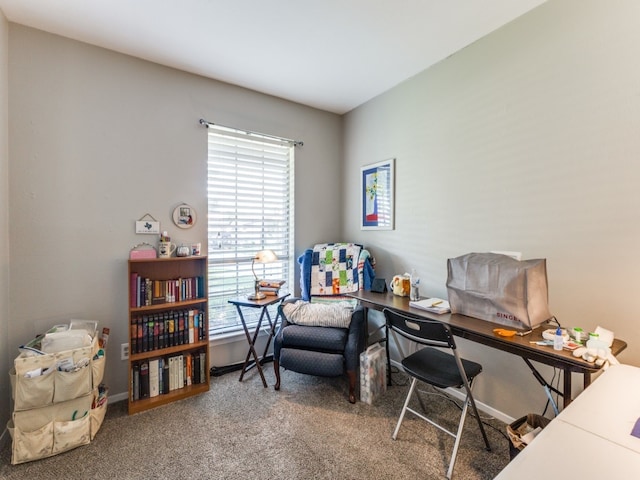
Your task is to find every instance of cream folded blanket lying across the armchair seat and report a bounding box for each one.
[282,300,353,328]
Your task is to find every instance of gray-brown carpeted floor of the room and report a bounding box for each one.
[0,364,509,480]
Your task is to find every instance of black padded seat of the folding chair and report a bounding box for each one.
[402,347,482,388]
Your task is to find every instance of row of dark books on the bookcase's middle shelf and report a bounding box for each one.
[129,309,208,353]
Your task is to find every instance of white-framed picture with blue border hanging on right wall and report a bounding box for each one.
[360,158,395,230]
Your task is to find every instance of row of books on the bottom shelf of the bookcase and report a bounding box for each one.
[131,352,207,401]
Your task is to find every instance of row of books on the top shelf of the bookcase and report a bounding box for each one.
[129,272,205,308]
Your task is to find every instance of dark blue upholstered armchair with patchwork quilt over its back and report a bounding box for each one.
[273,243,375,403]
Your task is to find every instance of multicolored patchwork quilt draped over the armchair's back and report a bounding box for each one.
[310,243,362,295]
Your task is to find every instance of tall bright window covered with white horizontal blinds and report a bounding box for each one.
[207,124,294,335]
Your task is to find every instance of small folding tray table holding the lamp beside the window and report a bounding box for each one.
[229,294,289,388]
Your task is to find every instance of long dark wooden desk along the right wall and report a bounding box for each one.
[349,290,627,407]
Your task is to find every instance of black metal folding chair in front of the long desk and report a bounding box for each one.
[384,309,491,479]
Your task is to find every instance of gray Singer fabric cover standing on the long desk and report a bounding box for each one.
[447,253,551,329]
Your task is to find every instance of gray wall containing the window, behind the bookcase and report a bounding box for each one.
[6,24,342,420]
